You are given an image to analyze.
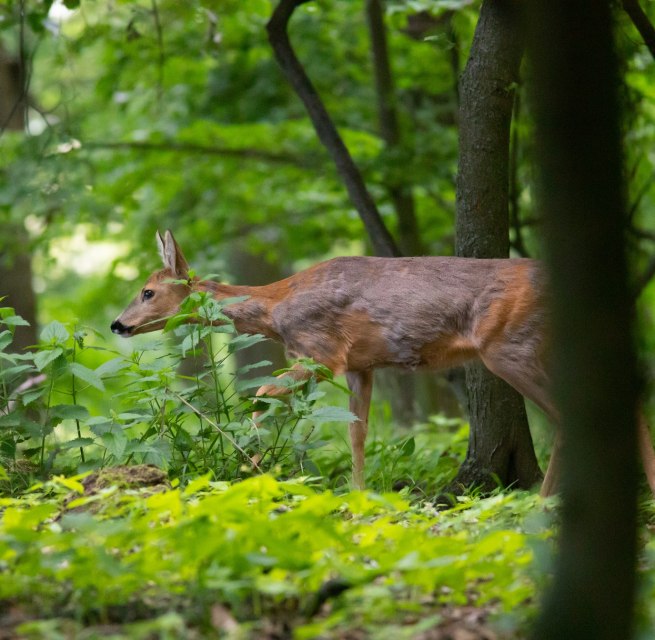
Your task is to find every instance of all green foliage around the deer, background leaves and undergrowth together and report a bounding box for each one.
[0,0,655,639]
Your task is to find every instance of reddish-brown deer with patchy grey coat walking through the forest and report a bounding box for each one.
[111,231,655,496]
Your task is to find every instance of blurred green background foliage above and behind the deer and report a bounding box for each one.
[0,0,655,418]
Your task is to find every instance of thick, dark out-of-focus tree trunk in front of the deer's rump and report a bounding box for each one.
[529,0,638,640]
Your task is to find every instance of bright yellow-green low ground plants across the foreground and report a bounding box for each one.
[0,467,552,639]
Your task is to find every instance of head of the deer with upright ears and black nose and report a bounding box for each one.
[111,231,191,338]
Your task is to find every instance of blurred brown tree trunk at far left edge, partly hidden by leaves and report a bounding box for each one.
[0,49,37,351]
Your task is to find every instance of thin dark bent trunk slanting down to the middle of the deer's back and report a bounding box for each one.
[266,0,400,256]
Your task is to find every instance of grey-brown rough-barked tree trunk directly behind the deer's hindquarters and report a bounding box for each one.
[453,0,541,490]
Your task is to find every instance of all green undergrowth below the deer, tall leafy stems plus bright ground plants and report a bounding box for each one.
[0,302,655,640]
